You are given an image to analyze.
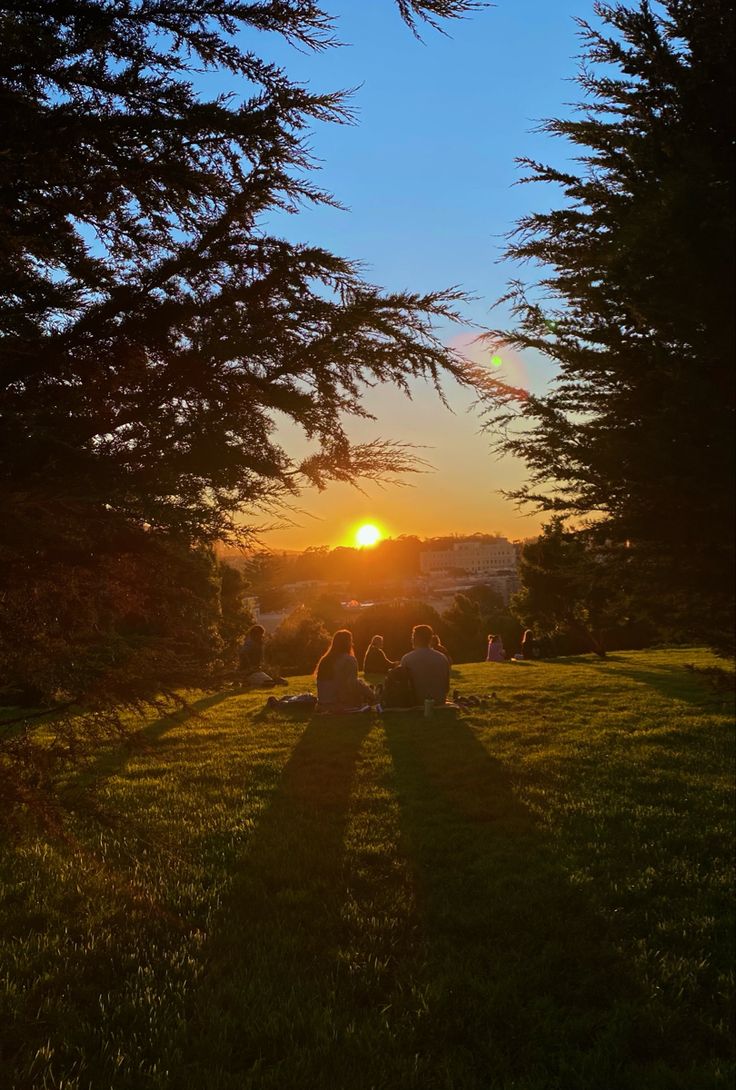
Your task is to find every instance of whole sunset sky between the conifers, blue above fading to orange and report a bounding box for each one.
[228,0,592,550]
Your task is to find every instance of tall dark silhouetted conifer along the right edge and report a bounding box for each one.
[486,0,735,650]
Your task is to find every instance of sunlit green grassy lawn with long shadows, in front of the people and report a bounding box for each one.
[0,650,734,1090]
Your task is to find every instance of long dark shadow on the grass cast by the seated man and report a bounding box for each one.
[386,719,639,1090]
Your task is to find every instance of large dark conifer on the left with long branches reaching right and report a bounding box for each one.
[0,0,478,741]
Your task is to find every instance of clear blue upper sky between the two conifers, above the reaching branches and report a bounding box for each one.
[256,0,591,323]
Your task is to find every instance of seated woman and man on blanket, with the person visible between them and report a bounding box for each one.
[316,625,450,712]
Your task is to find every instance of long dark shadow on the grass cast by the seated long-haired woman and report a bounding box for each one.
[177,716,373,1090]
